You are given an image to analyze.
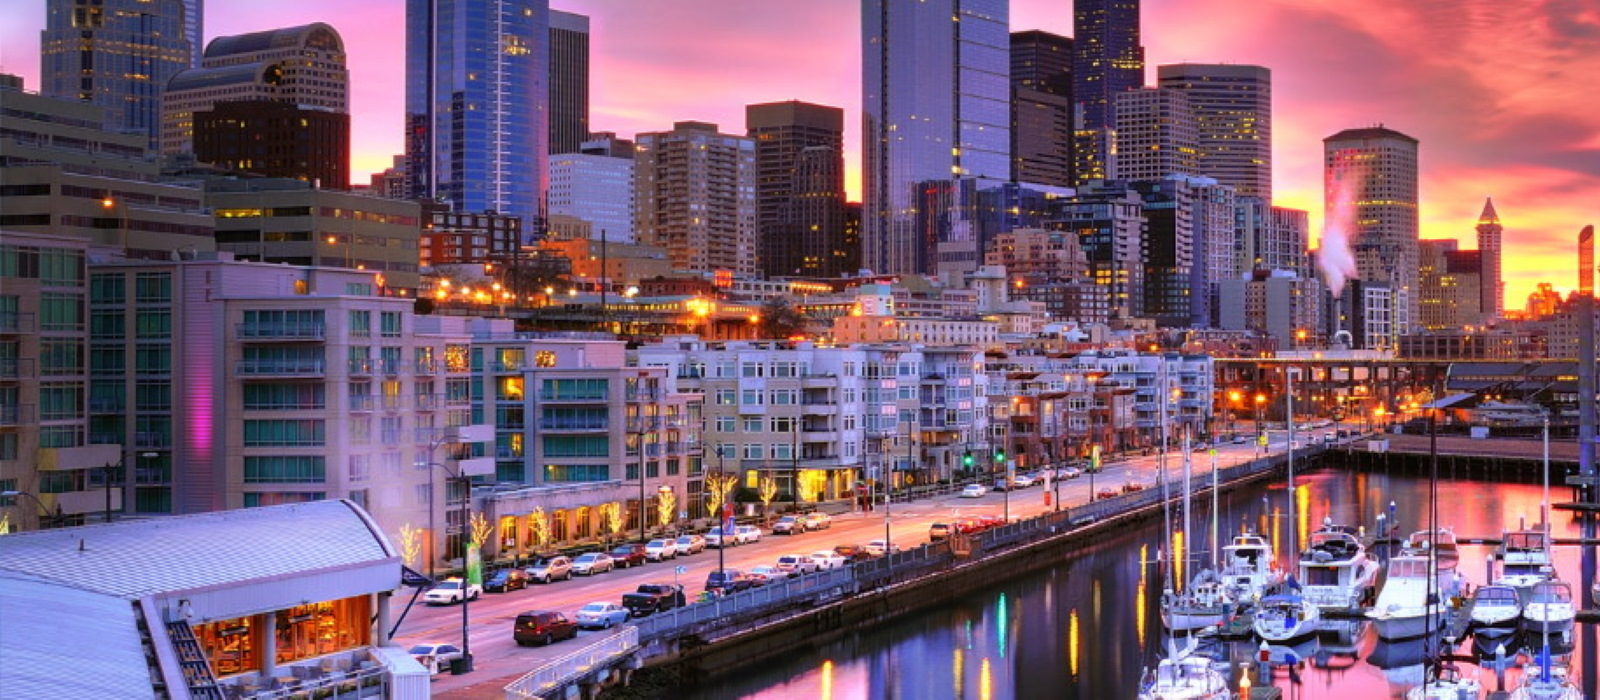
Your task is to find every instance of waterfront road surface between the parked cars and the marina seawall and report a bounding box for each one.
[392,427,1334,698]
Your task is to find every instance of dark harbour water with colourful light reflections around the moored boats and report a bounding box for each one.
[694,471,1595,700]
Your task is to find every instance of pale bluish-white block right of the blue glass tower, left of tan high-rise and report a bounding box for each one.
[549,134,635,243]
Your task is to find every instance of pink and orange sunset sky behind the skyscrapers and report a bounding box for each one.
[0,0,1600,308]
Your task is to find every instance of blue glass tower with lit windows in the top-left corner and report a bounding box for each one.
[38,0,198,149]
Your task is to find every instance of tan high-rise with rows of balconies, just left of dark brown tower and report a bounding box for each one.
[634,121,760,275]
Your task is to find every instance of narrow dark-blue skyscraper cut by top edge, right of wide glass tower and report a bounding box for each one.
[1072,0,1144,167]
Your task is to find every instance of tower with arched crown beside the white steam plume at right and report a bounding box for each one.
[1323,126,1421,332]
